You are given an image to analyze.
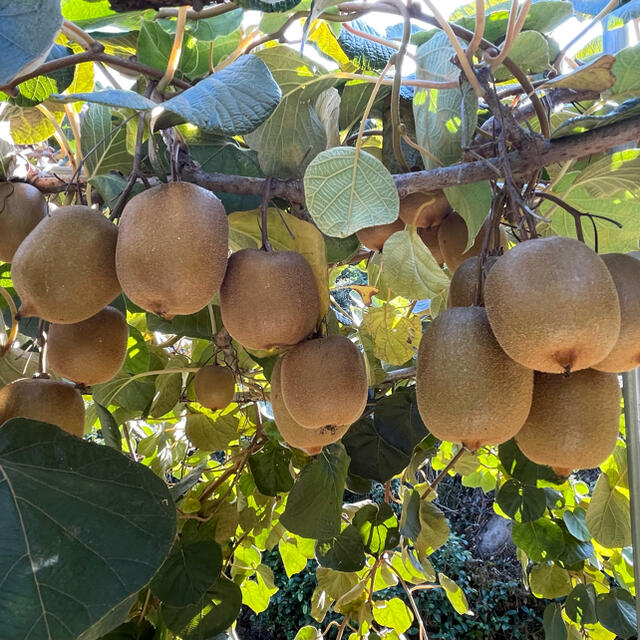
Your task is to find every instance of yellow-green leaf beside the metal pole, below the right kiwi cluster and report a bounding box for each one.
[585,473,631,548]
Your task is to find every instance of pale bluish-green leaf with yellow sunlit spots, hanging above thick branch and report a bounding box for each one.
[413,32,478,169]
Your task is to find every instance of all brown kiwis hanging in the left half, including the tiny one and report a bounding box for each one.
[0,182,367,453]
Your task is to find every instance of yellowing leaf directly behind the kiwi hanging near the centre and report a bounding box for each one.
[229,209,329,321]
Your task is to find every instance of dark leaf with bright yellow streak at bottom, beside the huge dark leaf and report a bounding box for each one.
[160,576,242,640]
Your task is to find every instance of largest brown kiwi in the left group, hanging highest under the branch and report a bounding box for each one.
[116,182,229,319]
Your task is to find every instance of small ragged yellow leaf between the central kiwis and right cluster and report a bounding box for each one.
[364,303,422,365]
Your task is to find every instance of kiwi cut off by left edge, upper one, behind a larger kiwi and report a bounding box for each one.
[0,182,47,262]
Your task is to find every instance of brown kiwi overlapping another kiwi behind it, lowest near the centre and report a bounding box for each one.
[282,336,367,429]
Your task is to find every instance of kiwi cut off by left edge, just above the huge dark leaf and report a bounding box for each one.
[0,378,84,438]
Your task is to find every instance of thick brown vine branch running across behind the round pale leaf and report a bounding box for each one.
[176,117,640,203]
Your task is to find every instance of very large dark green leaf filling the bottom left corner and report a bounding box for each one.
[0,418,176,640]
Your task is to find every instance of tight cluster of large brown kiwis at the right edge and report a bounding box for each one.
[416,237,640,475]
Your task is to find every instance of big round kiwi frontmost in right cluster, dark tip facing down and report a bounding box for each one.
[484,237,620,373]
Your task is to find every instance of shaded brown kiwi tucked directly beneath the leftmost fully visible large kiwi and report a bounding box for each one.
[47,307,129,385]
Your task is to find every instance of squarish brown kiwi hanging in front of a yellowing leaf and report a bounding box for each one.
[220,249,320,350]
